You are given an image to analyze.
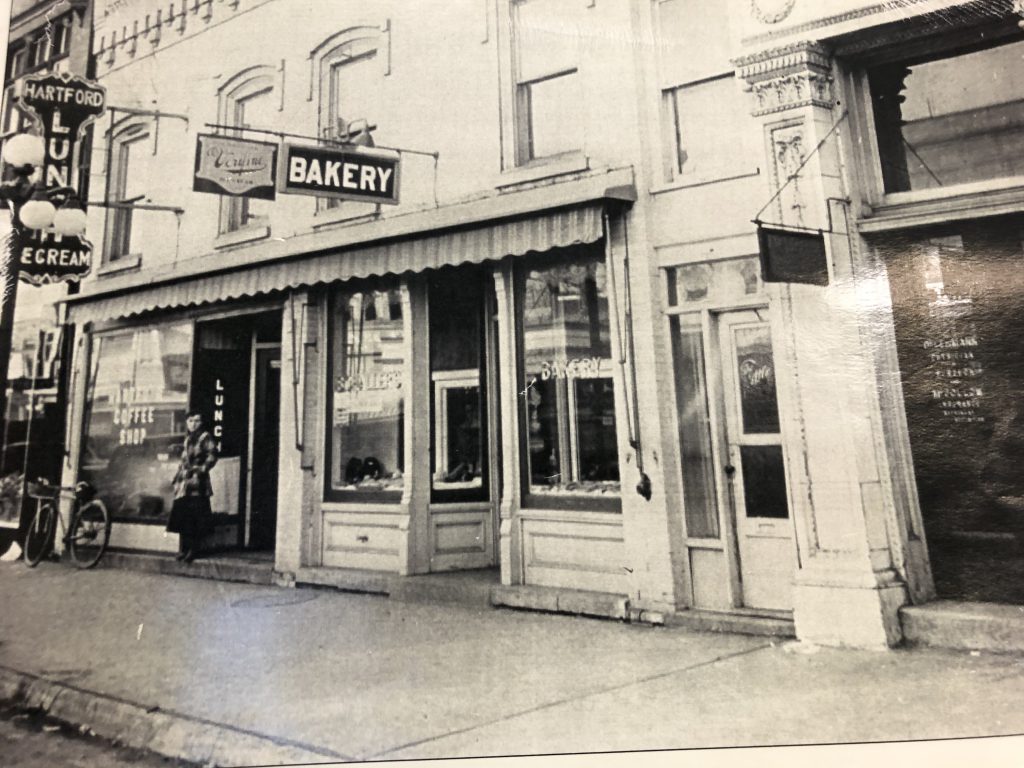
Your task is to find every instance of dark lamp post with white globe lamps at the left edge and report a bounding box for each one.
[0,133,85,434]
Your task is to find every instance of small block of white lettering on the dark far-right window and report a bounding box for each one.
[922,334,985,424]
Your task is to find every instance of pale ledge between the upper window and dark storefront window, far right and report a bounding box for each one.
[857,177,1024,234]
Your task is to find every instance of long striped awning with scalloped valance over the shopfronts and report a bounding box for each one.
[66,167,632,324]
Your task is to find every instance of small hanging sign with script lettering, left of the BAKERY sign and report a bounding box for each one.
[193,134,278,200]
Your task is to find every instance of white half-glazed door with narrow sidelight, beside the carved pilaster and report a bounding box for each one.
[670,307,797,611]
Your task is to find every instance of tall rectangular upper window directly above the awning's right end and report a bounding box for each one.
[511,0,584,165]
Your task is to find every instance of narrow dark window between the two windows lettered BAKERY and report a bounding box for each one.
[430,267,487,499]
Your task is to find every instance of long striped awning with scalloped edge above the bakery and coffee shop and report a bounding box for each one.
[65,167,633,324]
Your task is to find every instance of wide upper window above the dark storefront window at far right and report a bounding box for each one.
[867,38,1024,193]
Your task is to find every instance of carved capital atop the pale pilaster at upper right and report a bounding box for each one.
[733,42,834,115]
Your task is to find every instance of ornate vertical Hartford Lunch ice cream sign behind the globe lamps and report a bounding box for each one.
[17,73,106,286]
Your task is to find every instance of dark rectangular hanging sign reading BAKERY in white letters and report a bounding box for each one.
[278,142,399,205]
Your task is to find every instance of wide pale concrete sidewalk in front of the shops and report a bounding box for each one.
[0,563,1024,765]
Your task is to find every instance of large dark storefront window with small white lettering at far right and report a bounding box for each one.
[878,215,1024,603]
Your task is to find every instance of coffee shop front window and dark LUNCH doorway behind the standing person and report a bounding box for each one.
[71,305,282,551]
